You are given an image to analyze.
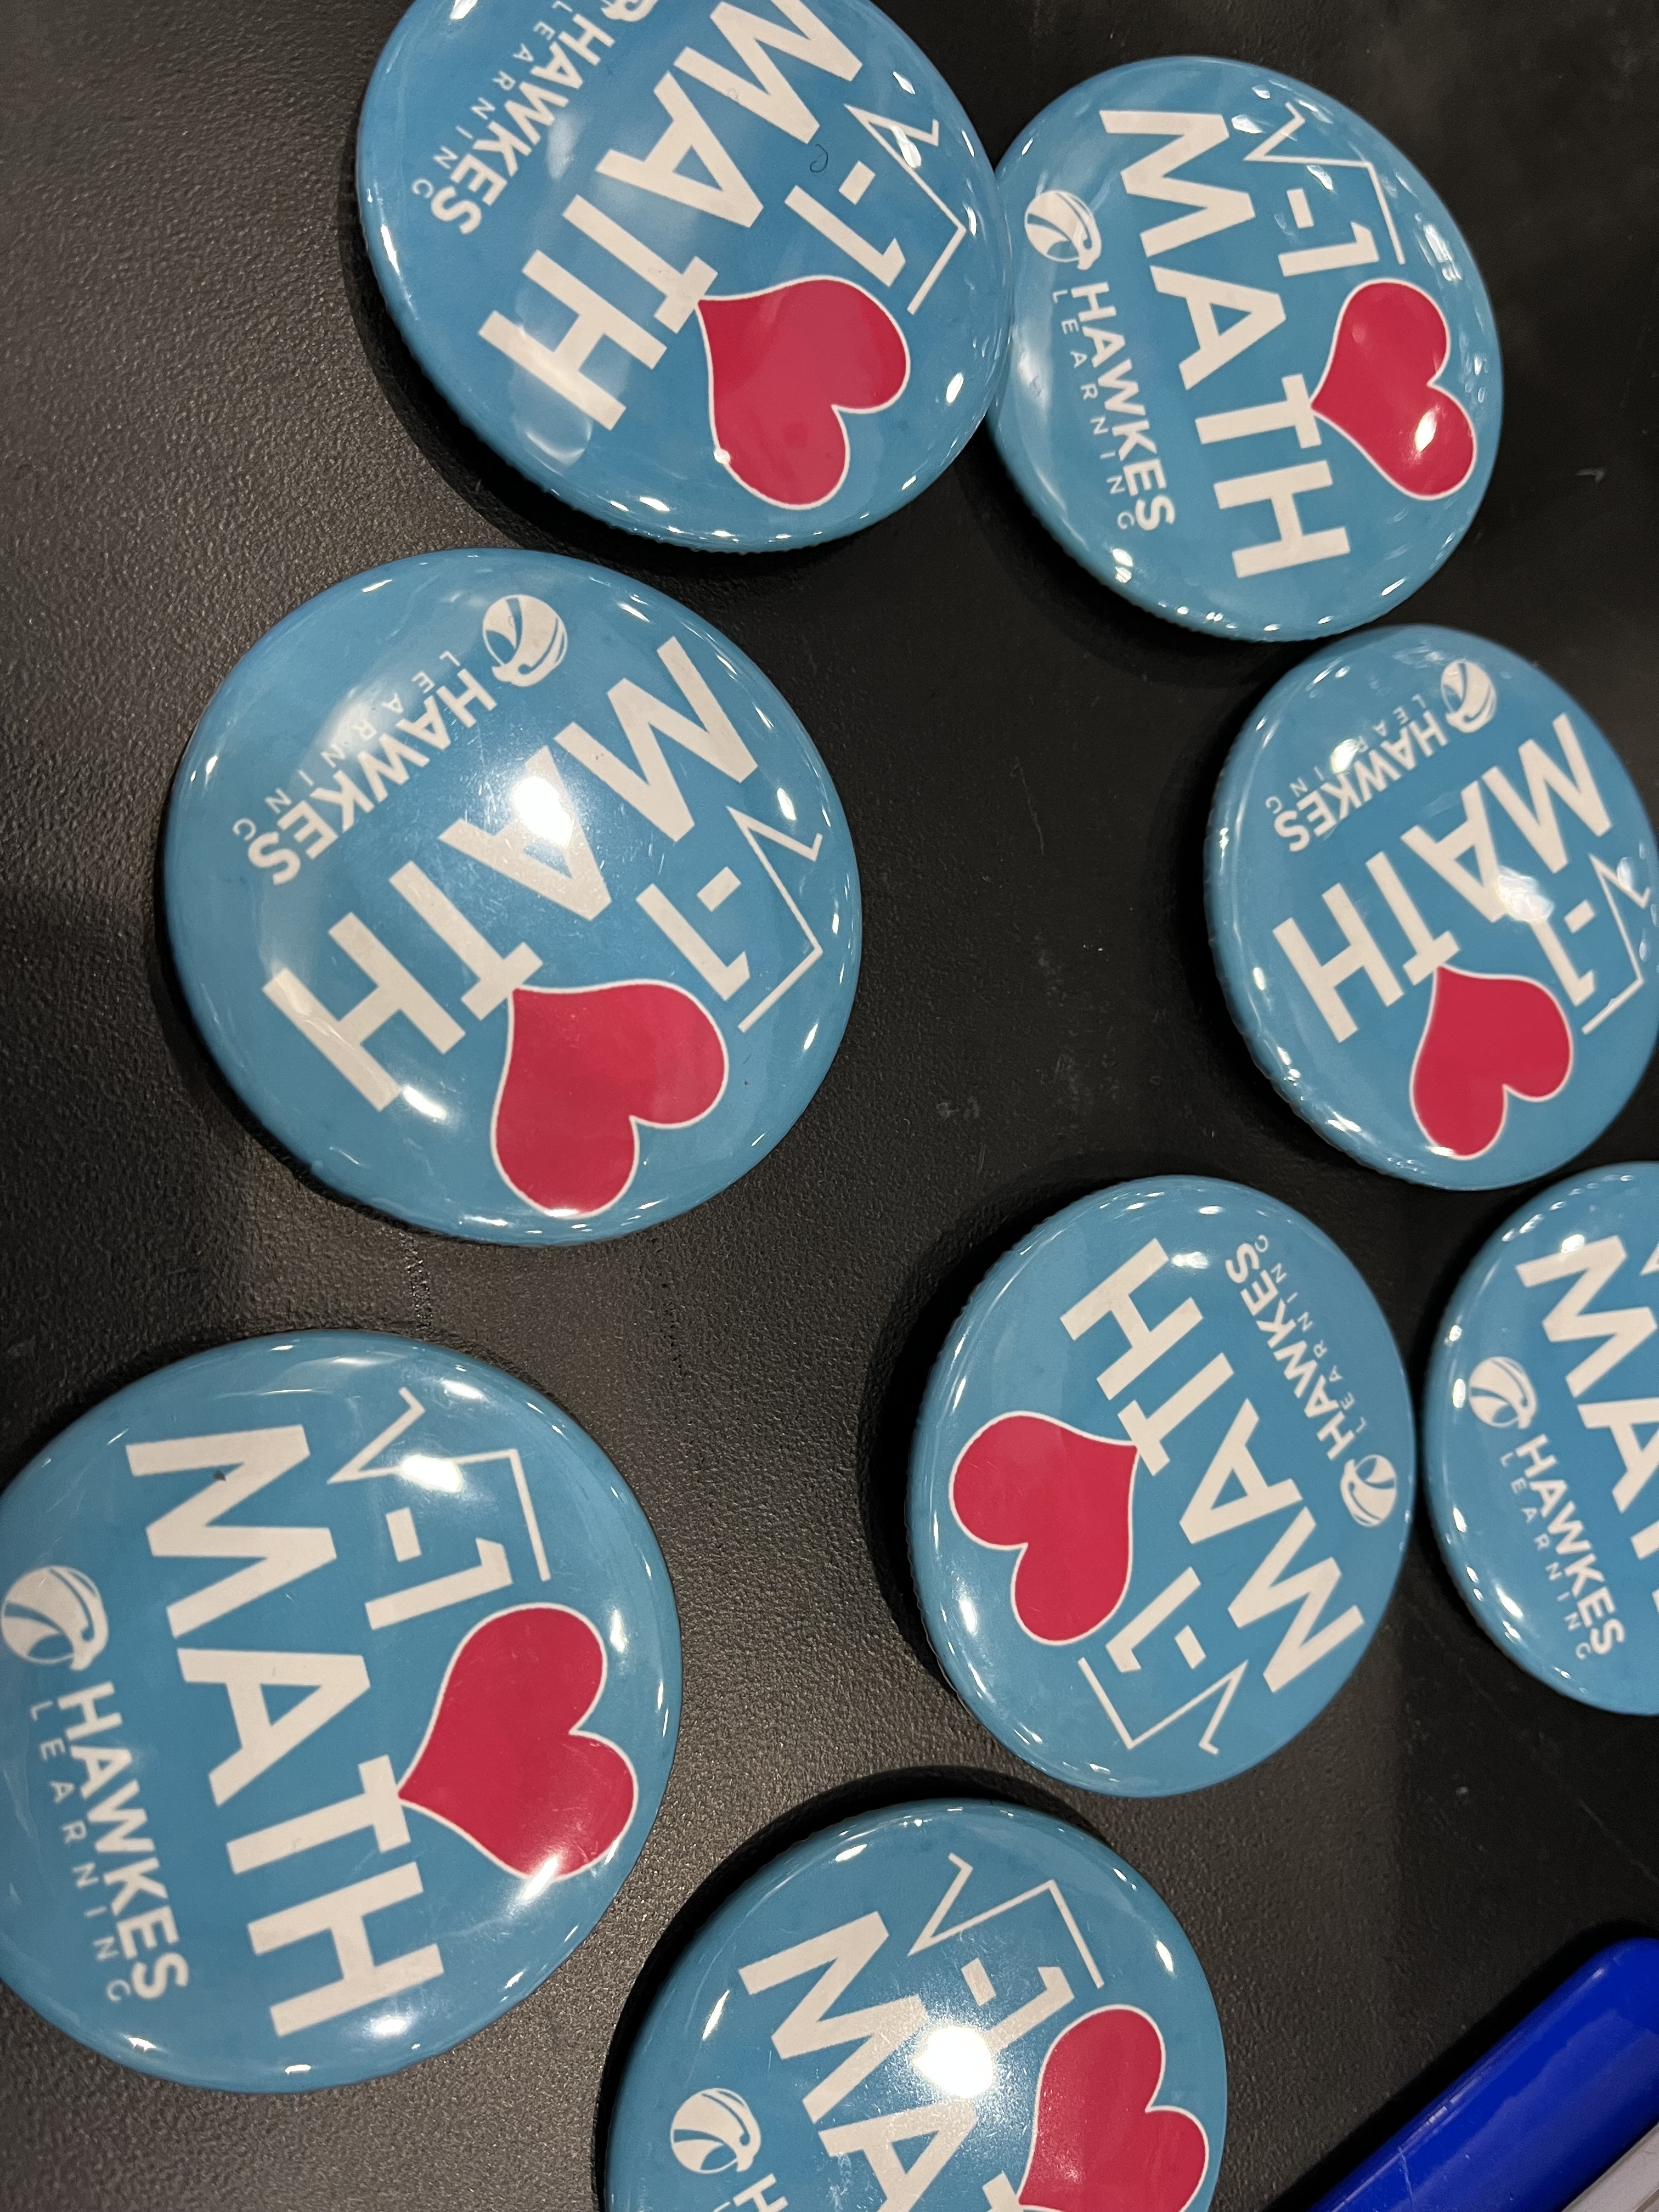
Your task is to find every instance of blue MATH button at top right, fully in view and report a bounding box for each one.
[991,58,1502,637]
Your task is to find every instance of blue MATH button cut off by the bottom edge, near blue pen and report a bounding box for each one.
[606,1801,1228,2212]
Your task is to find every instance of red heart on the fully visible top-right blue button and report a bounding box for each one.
[1314,279,1475,500]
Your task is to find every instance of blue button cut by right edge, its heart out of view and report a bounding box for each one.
[1423,1161,1659,1712]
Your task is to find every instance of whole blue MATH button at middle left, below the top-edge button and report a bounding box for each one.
[163,553,858,1243]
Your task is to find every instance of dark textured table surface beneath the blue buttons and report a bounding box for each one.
[0,0,1659,2212]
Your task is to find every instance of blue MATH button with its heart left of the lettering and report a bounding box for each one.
[909,1177,1413,1796]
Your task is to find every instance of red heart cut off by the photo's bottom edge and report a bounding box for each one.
[1020,2004,1210,2212]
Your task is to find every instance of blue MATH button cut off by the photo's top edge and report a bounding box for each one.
[356,0,1009,553]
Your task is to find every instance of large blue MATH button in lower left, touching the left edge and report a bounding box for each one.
[0,1334,679,2090]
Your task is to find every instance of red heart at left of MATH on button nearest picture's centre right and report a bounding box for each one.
[951,1413,1135,1644]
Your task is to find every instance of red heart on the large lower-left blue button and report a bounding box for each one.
[398,1606,639,1882]
